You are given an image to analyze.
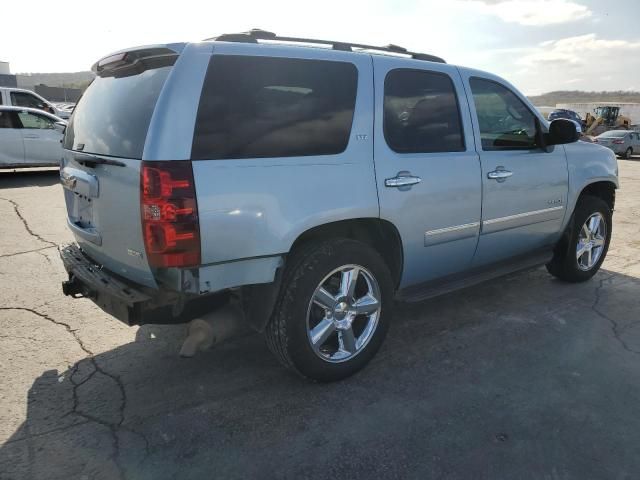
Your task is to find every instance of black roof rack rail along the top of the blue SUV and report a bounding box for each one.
[205,28,447,63]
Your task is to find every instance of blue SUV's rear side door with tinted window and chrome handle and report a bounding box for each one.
[373,56,481,287]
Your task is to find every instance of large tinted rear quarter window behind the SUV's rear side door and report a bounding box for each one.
[191,55,358,159]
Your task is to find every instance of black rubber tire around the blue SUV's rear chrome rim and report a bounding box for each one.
[265,239,394,382]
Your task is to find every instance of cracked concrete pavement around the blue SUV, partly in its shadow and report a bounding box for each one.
[0,159,640,479]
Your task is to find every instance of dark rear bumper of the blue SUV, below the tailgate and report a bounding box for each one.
[60,244,227,326]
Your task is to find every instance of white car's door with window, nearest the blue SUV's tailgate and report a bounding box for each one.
[17,111,62,165]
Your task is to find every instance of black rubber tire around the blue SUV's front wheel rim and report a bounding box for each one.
[547,195,613,283]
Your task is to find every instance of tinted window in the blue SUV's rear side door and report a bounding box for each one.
[384,69,464,153]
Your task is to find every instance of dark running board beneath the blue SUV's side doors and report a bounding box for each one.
[396,248,553,303]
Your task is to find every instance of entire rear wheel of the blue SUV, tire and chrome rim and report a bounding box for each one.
[265,239,393,382]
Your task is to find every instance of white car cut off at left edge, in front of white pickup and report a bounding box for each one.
[0,106,67,168]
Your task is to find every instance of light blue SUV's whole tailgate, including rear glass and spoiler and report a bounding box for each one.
[60,48,190,287]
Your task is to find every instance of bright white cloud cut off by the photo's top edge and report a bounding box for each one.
[470,0,592,26]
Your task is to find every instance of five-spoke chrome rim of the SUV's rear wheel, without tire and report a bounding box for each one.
[307,265,382,363]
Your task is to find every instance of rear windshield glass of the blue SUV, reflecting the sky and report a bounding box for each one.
[64,62,172,158]
